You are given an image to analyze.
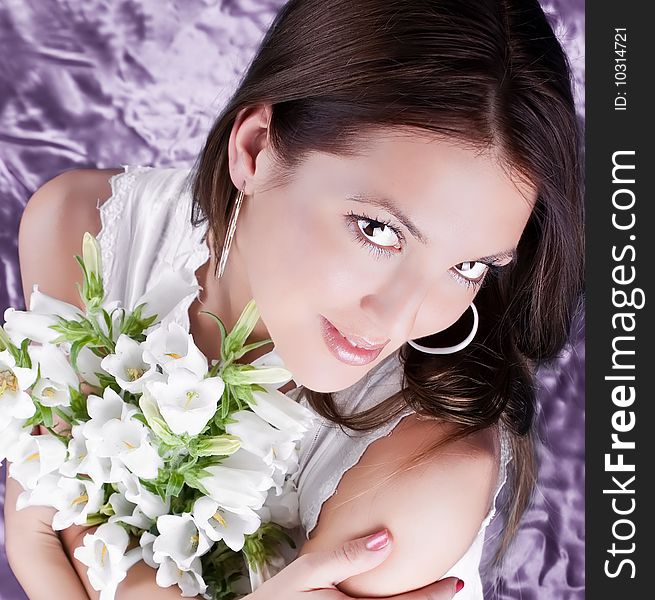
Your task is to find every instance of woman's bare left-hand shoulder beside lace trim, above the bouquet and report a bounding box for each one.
[18,168,123,305]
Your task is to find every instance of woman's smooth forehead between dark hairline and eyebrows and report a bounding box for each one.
[308,131,536,256]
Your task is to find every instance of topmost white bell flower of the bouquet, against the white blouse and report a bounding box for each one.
[129,263,200,327]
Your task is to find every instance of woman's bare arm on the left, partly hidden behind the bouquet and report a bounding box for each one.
[5,169,197,600]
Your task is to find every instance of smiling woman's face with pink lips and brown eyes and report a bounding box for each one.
[231,122,535,392]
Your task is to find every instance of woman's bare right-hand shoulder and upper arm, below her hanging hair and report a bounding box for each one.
[300,414,499,596]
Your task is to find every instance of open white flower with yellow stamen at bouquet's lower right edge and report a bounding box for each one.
[193,496,261,552]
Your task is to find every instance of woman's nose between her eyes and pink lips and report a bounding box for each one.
[360,263,434,340]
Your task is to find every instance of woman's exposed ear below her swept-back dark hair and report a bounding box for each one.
[228,104,272,194]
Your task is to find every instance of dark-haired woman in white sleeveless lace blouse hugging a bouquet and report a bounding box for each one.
[6,0,583,600]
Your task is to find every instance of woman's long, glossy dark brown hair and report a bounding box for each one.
[192,0,584,580]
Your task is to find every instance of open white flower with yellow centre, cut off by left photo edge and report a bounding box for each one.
[0,350,37,430]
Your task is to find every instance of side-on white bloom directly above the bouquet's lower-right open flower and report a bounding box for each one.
[200,448,274,511]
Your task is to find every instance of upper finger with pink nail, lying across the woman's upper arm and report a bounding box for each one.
[292,529,393,589]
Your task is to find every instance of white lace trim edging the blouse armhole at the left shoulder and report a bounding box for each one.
[96,165,152,292]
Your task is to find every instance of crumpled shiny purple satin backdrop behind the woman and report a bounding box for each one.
[0,0,584,600]
